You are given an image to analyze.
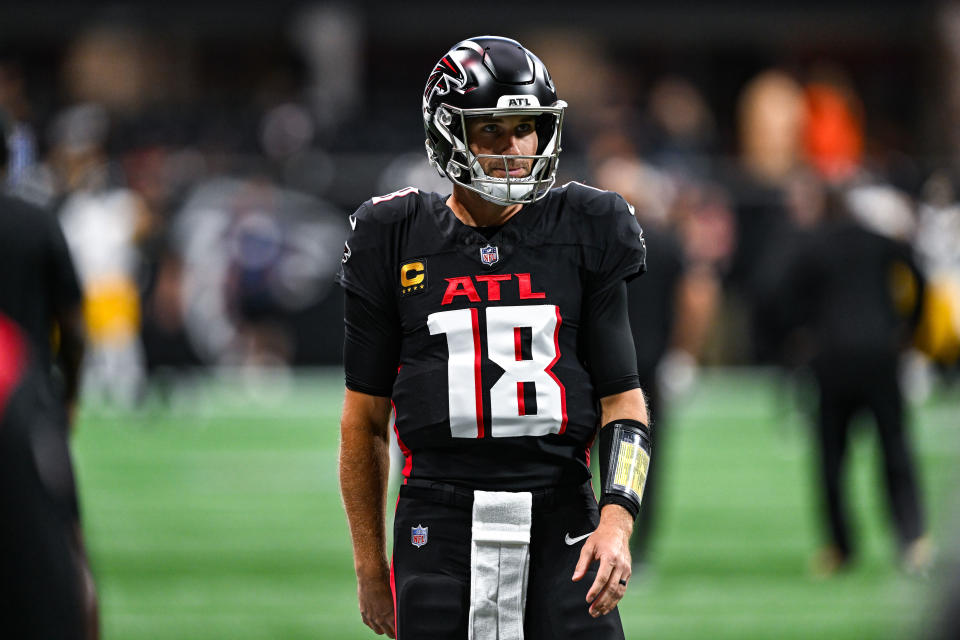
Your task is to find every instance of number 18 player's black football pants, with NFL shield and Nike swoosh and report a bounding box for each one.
[393,480,623,640]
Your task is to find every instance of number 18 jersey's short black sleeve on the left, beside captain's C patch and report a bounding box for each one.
[337,201,394,309]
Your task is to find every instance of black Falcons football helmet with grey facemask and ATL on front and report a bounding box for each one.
[423,36,567,205]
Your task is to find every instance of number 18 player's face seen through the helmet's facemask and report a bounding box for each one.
[466,115,537,178]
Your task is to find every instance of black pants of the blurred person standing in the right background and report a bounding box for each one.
[815,356,924,555]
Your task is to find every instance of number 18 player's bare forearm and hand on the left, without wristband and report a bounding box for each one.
[340,388,396,638]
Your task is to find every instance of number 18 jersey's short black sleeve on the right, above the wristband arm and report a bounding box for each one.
[575,181,647,290]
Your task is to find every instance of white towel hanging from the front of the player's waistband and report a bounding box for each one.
[468,491,533,640]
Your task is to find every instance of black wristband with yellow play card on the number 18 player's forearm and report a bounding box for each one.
[600,420,653,518]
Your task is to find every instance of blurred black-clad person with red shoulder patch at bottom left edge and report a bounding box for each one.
[0,313,88,640]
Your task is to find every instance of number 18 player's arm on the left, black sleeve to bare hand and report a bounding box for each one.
[338,198,401,638]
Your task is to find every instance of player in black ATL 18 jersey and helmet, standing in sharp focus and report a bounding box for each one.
[339,36,650,640]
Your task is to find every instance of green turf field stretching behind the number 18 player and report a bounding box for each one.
[75,371,960,640]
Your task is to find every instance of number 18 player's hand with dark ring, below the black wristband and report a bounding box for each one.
[573,504,633,618]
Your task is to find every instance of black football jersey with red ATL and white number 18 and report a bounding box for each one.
[339,183,644,490]
